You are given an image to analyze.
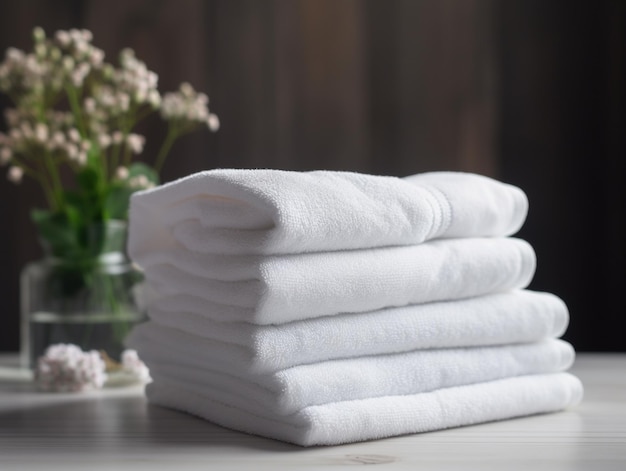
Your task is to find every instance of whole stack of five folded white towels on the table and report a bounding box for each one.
[128,170,582,446]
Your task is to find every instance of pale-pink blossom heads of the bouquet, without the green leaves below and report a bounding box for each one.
[0,28,219,199]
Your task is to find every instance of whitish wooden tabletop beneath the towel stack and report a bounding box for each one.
[0,354,626,471]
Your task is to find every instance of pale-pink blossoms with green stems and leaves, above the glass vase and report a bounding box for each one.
[0,28,219,268]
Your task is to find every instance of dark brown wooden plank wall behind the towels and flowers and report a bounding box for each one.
[0,0,626,350]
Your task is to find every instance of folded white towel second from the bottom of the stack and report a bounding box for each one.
[139,339,574,415]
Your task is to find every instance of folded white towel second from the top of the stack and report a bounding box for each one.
[135,238,535,324]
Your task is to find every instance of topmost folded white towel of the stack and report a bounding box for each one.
[129,169,528,256]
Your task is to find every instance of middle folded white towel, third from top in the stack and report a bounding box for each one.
[141,290,569,371]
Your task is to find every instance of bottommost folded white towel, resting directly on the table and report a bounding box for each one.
[146,373,583,446]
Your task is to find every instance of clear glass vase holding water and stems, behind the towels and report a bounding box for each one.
[20,220,144,368]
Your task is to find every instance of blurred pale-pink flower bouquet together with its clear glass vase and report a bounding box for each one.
[0,28,219,370]
